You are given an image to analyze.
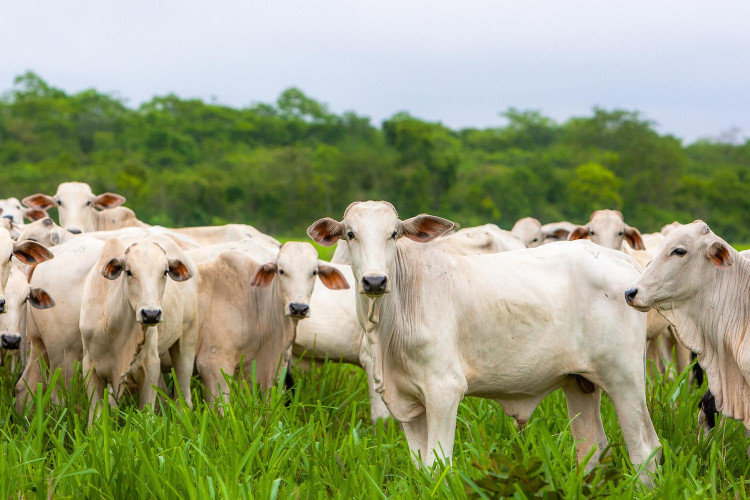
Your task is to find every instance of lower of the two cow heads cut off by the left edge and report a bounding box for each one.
[0,267,55,349]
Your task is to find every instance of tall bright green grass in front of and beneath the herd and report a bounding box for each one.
[0,356,750,499]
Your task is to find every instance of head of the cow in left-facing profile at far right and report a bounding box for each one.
[625,220,737,311]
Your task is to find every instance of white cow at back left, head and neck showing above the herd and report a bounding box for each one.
[23,182,148,234]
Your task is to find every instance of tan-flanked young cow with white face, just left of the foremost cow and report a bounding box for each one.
[196,242,349,401]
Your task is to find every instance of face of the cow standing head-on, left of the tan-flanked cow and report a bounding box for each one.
[102,242,192,326]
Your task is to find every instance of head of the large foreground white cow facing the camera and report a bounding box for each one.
[307,201,453,297]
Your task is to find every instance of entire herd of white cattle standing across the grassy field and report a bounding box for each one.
[0,182,750,481]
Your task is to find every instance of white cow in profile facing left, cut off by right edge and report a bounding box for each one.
[625,220,750,436]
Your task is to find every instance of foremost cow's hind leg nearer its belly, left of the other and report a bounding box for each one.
[562,375,607,472]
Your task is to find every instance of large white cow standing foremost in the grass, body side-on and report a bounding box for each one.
[308,201,660,479]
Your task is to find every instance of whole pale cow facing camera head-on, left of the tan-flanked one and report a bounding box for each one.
[80,238,198,424]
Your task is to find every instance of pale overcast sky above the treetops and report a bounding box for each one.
[0,0,750,142]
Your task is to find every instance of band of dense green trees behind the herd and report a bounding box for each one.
[0,73,750,242]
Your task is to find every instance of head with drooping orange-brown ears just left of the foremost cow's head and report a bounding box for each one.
[250,242,349,320]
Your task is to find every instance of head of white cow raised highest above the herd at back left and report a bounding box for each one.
[23,182,125,234]
